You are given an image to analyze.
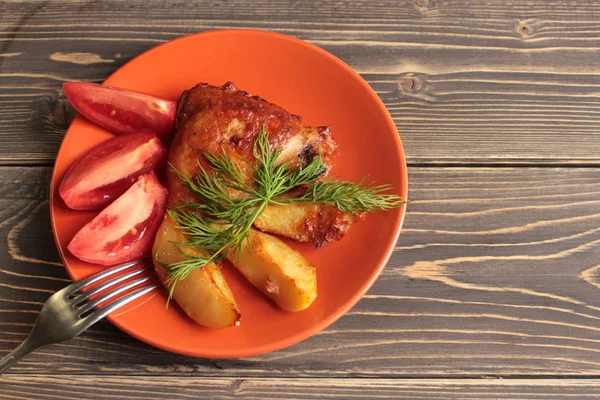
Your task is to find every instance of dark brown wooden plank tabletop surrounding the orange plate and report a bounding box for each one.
[0,0,600,399]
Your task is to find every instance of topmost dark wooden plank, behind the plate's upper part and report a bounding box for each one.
[0,0,600,165]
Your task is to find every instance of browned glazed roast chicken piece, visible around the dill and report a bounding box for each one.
[167,82,362,247]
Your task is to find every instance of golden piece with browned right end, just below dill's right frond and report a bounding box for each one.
[254,203,363,247]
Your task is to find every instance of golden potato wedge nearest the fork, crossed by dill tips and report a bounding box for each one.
[152,214,240,328]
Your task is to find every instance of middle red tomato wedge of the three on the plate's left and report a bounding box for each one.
[58,131,167,210]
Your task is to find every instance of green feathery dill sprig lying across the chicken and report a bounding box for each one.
[163,125,405,295]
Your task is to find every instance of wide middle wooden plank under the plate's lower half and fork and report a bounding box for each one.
[0,167,600,378]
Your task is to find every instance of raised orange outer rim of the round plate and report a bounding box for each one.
[49,29,408,359]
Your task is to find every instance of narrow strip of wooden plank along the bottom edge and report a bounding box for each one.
[0,375,600,400]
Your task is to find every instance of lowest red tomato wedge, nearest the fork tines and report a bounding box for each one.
[67,173,167,265]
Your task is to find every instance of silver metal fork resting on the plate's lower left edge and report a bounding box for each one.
[0,260,158,374]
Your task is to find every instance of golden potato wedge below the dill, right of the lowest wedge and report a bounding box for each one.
[227,229,317,311]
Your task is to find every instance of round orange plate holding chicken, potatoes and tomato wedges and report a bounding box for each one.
[50,30,408,357]
